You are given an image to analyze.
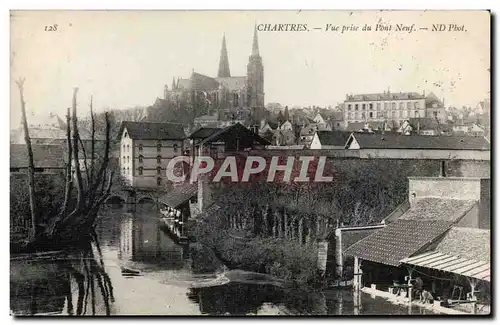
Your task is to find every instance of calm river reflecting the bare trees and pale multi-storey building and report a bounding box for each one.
[10,206,436,315]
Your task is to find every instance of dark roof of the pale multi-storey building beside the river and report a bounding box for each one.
[119,121,186,140]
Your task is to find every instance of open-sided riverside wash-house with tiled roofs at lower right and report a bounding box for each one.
[345,176,491,298]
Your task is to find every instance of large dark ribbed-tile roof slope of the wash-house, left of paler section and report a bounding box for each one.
[345,220,452,266]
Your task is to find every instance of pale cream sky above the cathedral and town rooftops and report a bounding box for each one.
[10,11,490,127]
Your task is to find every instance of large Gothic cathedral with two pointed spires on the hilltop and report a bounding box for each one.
[164,29,264,119]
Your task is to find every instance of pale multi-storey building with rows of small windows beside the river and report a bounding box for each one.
[119,121,186,189]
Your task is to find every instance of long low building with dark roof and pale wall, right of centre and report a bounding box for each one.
[346,132,490,160]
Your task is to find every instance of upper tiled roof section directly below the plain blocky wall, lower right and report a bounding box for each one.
[398,198,477,222]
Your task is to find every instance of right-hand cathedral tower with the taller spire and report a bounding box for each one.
[247,27,264,108]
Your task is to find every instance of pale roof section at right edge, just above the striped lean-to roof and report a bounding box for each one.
[434,227,491,262]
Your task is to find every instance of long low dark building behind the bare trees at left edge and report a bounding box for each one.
[10,144,66,174]
